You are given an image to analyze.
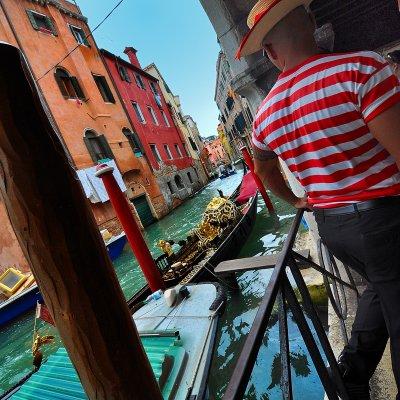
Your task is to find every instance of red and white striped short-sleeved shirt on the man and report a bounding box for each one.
[253,52,400,208]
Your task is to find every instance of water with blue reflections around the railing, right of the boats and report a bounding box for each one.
[210,195,323,400]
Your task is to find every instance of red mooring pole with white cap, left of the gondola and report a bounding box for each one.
[96,164,165,292]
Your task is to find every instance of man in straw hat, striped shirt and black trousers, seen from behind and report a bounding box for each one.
[238,0,400,400]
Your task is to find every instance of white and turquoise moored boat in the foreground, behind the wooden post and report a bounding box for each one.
[1,284,225,400]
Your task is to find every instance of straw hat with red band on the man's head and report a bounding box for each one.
[236,0,312,59]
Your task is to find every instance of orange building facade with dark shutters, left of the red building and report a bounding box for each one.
[0,0,167,269]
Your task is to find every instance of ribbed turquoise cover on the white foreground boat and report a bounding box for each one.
[11,335,186,400]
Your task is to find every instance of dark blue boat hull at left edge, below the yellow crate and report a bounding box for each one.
[0,285,43,327]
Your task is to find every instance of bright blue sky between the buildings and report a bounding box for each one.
[77,0,220,136]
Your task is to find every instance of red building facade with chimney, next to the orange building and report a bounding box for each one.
[101,47,200,208]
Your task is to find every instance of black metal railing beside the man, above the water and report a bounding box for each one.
[223,211,358,400]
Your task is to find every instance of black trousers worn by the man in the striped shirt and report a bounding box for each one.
[314,204,400,400]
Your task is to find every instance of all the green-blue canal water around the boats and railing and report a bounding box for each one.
[0,173,323,400]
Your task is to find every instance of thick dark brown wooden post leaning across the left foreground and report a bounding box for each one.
[0,44,162,400]
